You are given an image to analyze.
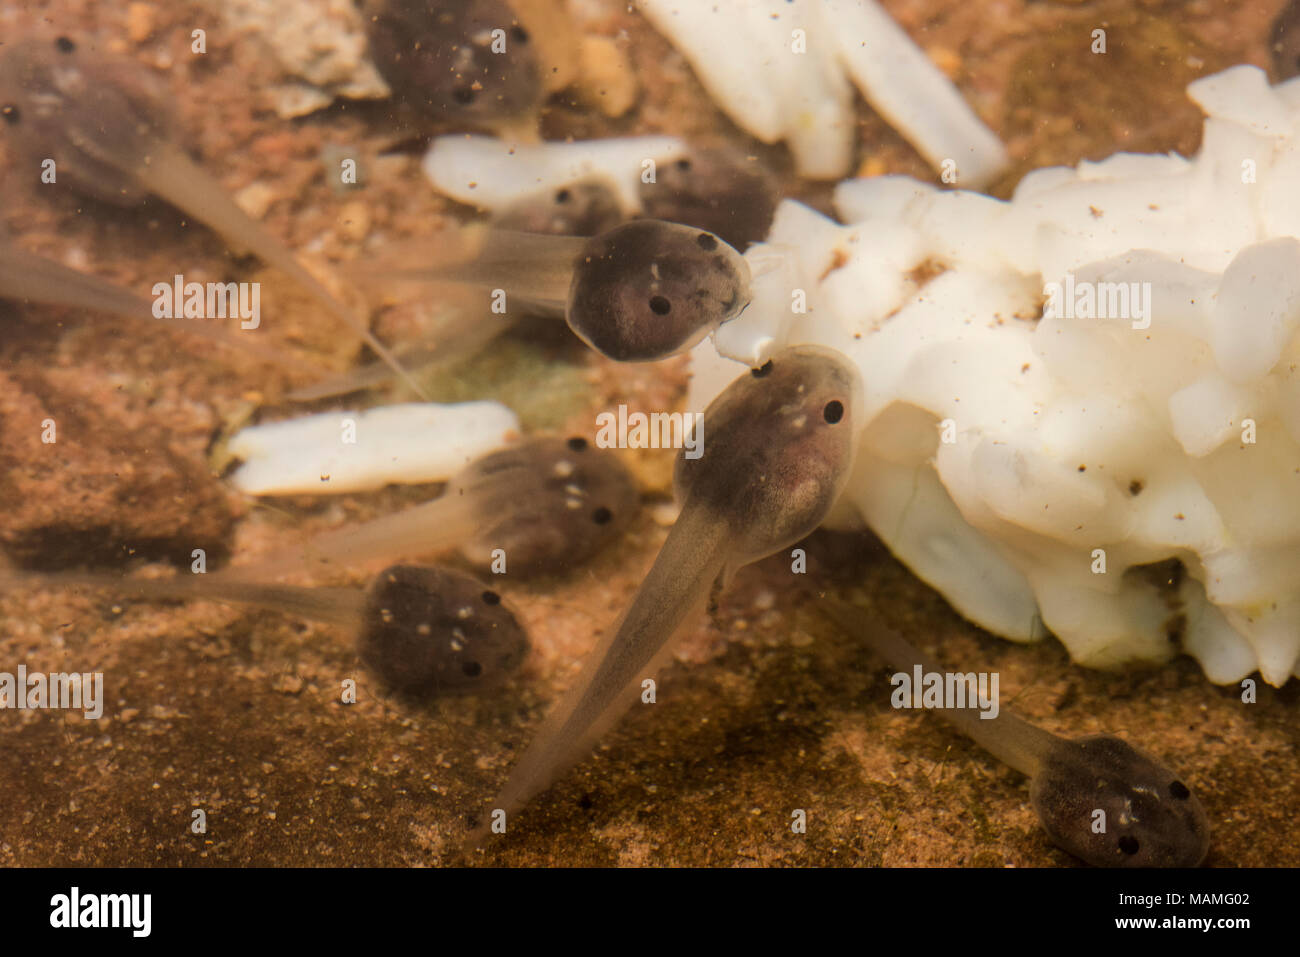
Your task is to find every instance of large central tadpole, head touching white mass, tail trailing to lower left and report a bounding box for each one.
[471,346,862,840]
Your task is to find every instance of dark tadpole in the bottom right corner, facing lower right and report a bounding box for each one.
[822,598,1210,867]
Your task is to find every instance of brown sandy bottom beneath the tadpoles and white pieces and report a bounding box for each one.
[0,0,1300,866]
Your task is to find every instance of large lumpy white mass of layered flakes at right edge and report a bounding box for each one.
[688,68,1300,685]
